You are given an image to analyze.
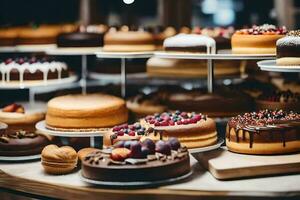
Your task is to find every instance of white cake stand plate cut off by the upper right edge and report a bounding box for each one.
[257,60,300,73]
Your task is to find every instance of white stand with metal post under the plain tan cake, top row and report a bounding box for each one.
[96,51,153,98]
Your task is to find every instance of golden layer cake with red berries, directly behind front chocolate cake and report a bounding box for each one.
[141,111,217,148]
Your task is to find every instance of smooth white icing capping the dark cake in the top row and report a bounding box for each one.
[163,33,216,53]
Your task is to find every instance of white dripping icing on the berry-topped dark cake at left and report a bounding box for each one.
[0,61,67,83]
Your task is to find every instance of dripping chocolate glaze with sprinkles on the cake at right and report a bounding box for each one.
[226,110,300,148]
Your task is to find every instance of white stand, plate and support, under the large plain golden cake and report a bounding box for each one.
[35,120,108,148]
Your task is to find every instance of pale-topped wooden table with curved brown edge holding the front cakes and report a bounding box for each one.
[0,157,300,200]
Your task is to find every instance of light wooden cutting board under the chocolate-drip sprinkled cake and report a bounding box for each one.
[193,147,300,179]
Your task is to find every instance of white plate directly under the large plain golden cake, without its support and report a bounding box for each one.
[35,120,108,137]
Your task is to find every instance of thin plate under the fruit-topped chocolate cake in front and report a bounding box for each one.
[79,170,193,188]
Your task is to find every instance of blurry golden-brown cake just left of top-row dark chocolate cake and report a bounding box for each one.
[17,25,61,45]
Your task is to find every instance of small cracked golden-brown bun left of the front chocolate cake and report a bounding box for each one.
[41,144,78,174]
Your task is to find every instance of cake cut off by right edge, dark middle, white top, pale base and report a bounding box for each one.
[276,30,300,66]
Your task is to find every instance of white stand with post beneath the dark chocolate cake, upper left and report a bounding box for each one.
[46,47,101,94]
